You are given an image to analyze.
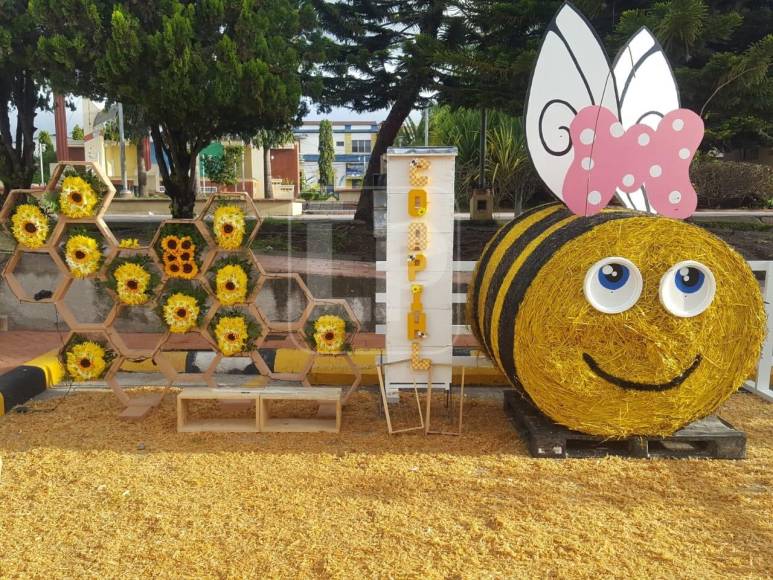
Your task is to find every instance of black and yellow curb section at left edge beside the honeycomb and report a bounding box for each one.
[0,350,64,416]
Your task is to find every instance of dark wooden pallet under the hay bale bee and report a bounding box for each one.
[504,390,746,459]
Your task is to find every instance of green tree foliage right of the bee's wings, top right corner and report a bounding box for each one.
[609,0,773,152]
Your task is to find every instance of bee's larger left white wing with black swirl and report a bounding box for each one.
[525,3,618,200]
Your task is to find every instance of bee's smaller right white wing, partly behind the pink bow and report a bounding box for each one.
[612,28,679,213]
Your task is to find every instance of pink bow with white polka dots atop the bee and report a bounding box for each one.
[563,106,703,219]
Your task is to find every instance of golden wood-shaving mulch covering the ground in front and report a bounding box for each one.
[0,392,773,578]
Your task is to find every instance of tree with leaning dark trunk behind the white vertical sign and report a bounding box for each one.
[313,0,465,225]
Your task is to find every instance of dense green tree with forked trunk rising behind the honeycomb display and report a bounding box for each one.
[30,0,313,217]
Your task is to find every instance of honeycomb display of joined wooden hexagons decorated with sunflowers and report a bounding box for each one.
[0,161,362,420]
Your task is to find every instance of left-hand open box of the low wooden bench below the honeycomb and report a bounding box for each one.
[177,387,263,433]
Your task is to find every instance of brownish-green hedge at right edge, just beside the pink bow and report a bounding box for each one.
[690,159,773,209]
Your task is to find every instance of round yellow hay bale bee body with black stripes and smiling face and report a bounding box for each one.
[467,204,765,437]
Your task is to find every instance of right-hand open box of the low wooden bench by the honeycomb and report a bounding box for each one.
[258,387,341,433]
